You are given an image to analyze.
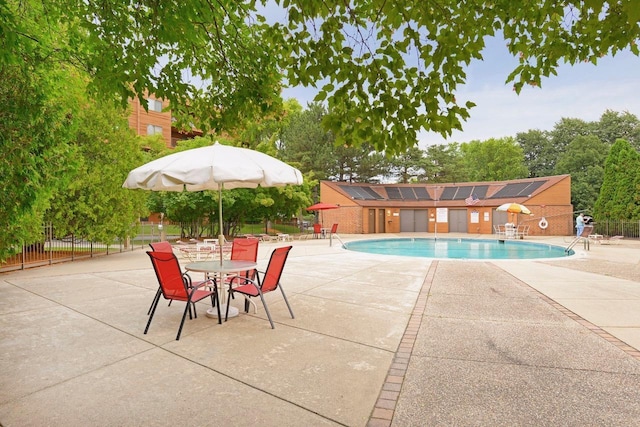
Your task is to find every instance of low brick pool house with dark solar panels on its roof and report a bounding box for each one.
[320,175,574,236]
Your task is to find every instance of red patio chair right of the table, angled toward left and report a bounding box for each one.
[224,246,295,329]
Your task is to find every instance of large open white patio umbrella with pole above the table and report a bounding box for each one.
[122,142,302,262]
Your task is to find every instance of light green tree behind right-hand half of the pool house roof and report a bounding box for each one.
[460,138,528,181]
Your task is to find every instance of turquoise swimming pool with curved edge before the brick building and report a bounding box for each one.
[344,238,575,259]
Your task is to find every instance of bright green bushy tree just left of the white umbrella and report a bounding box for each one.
[46,103,146,244]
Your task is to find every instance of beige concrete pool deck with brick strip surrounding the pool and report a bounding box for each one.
[0,234,640,427]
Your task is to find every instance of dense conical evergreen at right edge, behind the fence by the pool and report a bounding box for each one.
[593,139,640,220]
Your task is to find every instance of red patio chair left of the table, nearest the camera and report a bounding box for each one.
[144,251,221,341]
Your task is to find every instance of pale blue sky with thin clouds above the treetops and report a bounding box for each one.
[283,39,640,149]
